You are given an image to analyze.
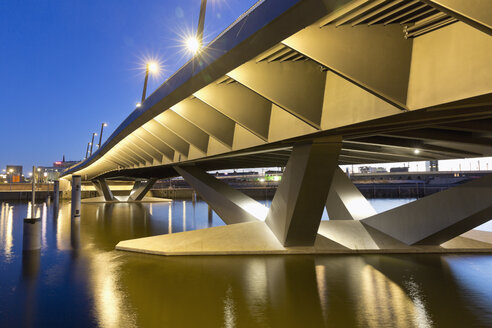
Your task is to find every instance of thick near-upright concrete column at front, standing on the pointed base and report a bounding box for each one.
[265,138,342,246]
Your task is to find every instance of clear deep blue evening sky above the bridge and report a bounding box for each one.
[0,0,256,172]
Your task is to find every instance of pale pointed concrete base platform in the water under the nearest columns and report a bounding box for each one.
[116,221,492,255]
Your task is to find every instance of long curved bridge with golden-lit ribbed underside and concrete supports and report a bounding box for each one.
[64,0,492,255]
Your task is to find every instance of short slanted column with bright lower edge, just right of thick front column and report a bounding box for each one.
[326,168,377,220]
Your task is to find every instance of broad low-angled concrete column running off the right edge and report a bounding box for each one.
[361,175,492,245]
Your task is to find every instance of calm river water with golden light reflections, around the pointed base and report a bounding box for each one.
[0,200,492,327]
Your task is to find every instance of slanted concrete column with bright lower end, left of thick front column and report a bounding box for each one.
[174,166,268,224]
